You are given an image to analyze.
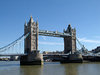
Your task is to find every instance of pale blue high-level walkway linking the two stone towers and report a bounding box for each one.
[39,30,71,37]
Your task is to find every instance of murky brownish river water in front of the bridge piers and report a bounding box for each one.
[0,61,100,75]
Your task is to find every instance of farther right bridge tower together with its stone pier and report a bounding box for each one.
[61,24,83,63]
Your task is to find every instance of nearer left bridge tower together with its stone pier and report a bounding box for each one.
[20,16,43,65]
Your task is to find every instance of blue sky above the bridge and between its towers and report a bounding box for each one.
[0,0,100,51]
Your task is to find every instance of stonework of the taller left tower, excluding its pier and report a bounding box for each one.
[24,17,38,53]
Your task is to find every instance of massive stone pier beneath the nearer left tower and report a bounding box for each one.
[20,51,43,65]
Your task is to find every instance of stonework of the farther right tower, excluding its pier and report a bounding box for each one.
[64,24,76,54]
